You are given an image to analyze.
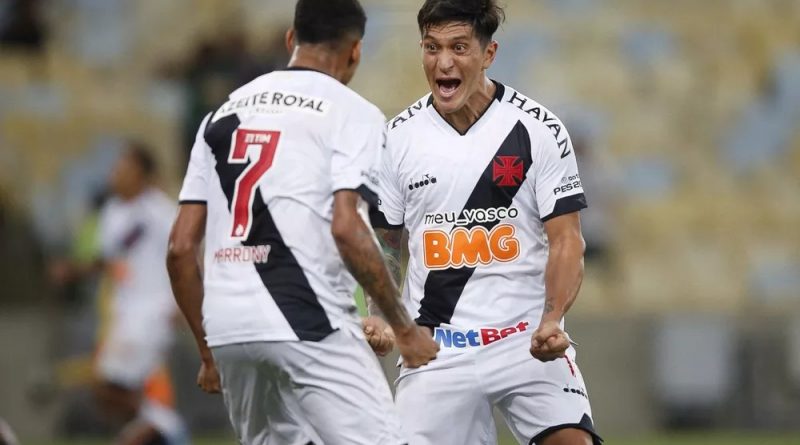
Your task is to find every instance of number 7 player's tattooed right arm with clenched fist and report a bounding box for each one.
[331,190,439,368]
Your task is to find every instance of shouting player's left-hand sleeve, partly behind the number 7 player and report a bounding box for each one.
[373,128,405,228]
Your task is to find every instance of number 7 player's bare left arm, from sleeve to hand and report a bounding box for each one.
[167,204,219,392]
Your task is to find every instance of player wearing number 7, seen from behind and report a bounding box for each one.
[167,0,437,445]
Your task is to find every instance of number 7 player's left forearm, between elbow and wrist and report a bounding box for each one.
[167,246,211,361]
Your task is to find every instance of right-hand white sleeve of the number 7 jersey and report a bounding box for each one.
[331,106,386,207]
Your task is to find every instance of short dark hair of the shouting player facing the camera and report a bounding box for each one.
[417,0,506,45]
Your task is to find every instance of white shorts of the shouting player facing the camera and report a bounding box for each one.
[396,333,601,445]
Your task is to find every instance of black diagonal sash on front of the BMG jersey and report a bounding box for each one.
[416,122,533,327]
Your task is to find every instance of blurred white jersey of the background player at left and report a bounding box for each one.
[99,188,176,325]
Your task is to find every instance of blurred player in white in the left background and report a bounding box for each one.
[53,143,186,445]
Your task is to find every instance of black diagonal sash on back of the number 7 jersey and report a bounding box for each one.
[205,115,333,341]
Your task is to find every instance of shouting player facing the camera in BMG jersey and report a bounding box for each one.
[374,0,600,445]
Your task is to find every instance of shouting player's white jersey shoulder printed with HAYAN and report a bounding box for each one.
[498,84,571,156]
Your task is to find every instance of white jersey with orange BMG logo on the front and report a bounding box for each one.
[374,83,586,354]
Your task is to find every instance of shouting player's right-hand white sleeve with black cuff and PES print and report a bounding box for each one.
[535,127,587,222]
